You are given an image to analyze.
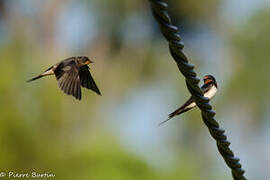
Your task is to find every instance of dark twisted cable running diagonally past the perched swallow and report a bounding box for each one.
[149,0,246,180]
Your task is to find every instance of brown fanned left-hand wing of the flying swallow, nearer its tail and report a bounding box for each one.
[54,61,81,100]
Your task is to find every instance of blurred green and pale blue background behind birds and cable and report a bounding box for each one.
[0,0,270,180]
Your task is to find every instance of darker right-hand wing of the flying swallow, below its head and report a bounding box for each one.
[79,65,101,95]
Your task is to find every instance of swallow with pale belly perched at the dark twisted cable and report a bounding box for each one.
[159,75,218,125]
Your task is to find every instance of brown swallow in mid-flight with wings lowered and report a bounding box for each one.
[27,56,101,100]
